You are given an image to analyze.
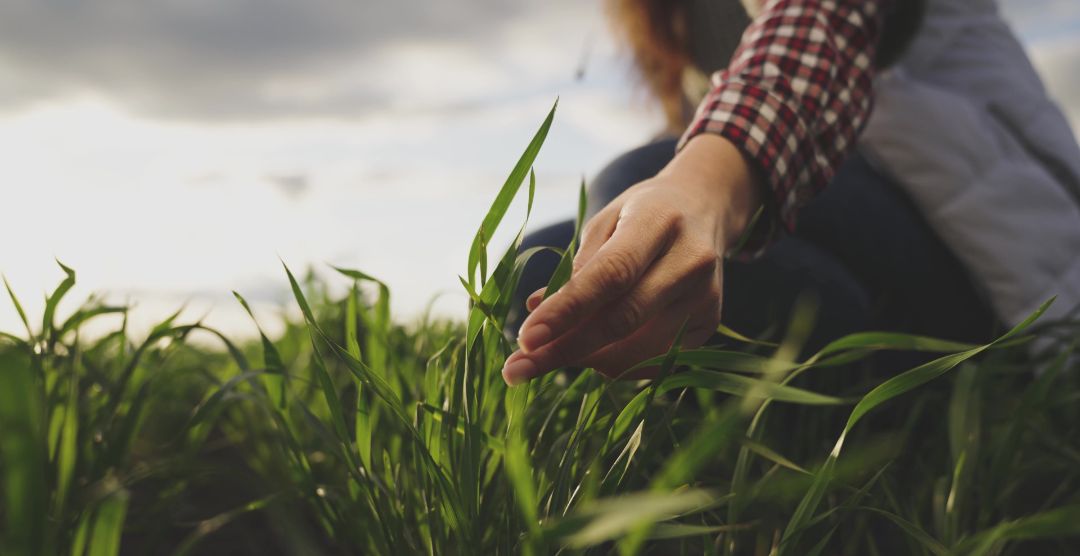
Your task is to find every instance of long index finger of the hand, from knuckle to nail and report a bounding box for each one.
[517,206,672,353]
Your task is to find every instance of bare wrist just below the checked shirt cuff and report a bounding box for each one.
[660,134,765,255]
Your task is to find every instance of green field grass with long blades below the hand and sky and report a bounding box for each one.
[0,102,1080,556]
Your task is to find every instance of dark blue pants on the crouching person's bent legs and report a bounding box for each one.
[510,139,996,348]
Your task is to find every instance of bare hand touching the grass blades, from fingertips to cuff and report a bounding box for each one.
[502,134,760,384]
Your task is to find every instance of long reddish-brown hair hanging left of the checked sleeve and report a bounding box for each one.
[607,0,690,132]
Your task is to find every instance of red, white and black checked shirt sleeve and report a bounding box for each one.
[679,0,889,255]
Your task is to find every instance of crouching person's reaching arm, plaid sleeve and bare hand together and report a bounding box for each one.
[502,0,886,384]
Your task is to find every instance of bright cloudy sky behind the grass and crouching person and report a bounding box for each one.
[0,0,1080,334]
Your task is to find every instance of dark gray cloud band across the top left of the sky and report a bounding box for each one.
[0,0,557,120]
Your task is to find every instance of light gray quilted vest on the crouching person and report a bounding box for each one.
[859,0,1080,325]
